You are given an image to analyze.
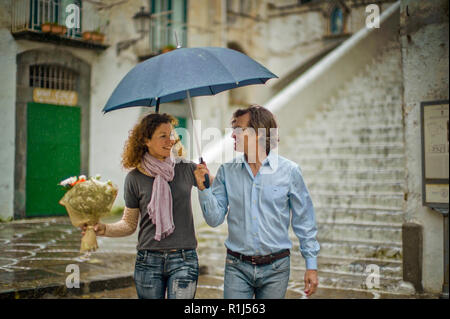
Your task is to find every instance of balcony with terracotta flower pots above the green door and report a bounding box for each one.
[11,0,108,50]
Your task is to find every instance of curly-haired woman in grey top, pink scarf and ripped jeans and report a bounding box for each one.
[83,114,202,299]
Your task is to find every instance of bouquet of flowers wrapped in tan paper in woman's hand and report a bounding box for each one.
[59,175,118,252]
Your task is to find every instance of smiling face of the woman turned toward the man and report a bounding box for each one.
[145,123,175,161]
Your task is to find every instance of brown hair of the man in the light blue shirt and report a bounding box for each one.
[233,104,279,155]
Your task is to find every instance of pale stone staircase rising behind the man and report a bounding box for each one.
[279,41,414,293]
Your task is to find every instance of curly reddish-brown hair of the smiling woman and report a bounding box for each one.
[122,113,178,169]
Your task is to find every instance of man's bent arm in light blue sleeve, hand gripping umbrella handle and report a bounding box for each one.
[196,165,228,227]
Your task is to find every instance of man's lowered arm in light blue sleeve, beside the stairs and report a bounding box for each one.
[289,165,320,270]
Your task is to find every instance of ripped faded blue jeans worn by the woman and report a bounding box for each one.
[134,249,198,299]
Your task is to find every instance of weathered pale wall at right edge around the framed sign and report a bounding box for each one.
[400,0,449,292]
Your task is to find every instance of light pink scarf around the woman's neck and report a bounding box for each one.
[141,152,175,241]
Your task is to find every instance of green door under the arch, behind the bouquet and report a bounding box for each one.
[26,103,81,217]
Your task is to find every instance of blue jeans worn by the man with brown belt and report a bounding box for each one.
[223,254,290,299]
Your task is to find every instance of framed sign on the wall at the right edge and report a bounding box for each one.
[420,100,449,209]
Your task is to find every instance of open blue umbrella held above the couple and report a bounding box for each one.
[103,47,277,187]
